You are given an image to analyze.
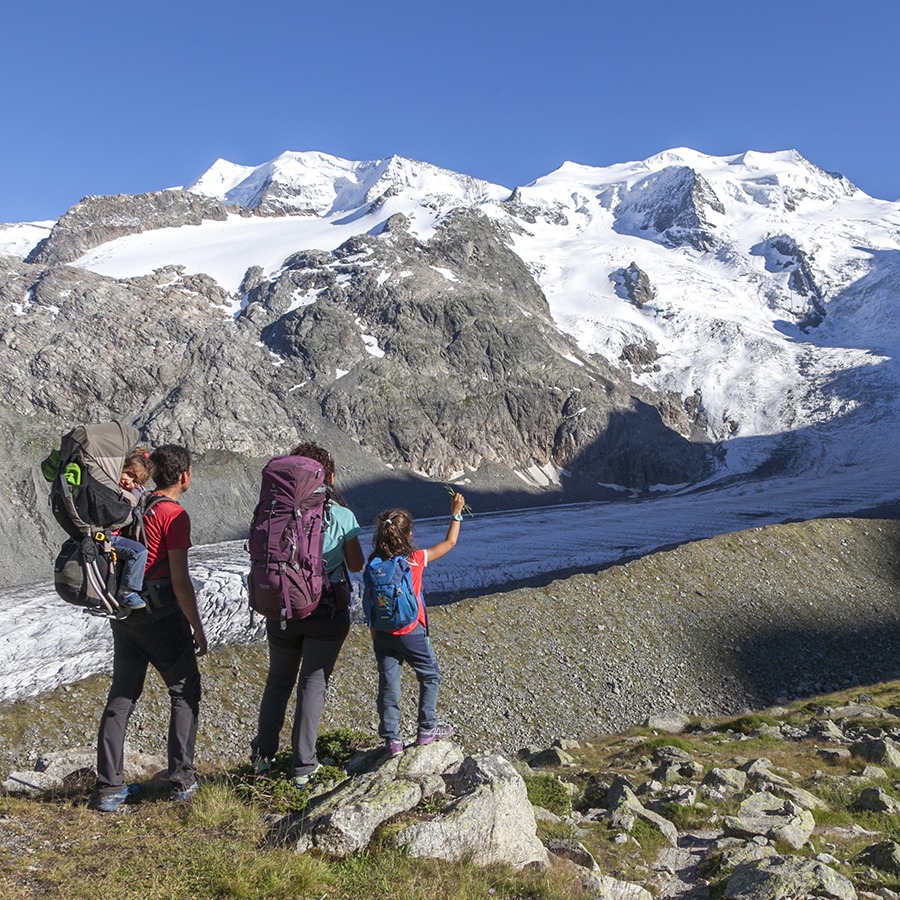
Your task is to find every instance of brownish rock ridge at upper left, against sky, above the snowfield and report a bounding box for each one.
[28,191,227,266]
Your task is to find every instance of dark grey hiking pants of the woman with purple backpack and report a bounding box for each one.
[251,610,350,775]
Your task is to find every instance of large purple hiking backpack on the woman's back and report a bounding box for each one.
[247,456,328,628]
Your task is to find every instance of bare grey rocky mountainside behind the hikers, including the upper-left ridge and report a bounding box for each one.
[0,191,715,583]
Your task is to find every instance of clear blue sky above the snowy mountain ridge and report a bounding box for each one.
[0,0,900,222]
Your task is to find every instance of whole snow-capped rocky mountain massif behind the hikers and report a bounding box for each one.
[0,148,900,584]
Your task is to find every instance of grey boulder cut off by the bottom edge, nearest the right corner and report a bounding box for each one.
[725,857,856,900]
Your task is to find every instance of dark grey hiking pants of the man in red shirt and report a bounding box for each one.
[97,609,200,794]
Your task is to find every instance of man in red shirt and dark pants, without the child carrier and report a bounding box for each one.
[95,444,206,812]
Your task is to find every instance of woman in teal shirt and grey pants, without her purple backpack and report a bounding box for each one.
[251,443,365,787]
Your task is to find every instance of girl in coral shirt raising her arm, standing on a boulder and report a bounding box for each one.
[369,494,466,756]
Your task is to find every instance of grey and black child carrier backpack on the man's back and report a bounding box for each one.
[41,422,138,616]
